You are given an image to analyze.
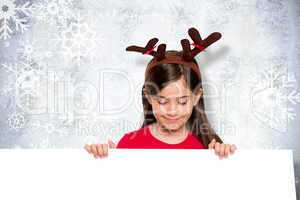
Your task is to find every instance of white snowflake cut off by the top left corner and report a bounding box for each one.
[0,0,32,40]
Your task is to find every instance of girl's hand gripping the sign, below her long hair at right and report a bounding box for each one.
[208,139,236,159]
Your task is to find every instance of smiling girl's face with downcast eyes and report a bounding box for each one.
[146,76,202,131]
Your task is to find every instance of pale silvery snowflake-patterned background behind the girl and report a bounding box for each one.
[0,0,300,193]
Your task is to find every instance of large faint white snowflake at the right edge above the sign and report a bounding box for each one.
[251,66,300,132]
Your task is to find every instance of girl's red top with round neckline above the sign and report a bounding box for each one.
[116,125,205,149]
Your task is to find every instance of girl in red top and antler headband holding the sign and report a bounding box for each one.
[85,28,236,159]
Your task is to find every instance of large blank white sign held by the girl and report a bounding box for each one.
[0,149,296,200]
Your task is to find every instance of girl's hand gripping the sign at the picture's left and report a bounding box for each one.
[84,140,117,158]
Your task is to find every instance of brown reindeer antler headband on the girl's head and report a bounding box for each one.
[126,28,222,79]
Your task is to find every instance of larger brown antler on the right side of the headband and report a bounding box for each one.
[181,28,222,61]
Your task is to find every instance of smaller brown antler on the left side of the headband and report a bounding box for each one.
[126,38,166,61]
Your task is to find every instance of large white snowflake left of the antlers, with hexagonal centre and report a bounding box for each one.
[57,15,97,65]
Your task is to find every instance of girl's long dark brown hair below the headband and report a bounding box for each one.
[142,63,223,148]
